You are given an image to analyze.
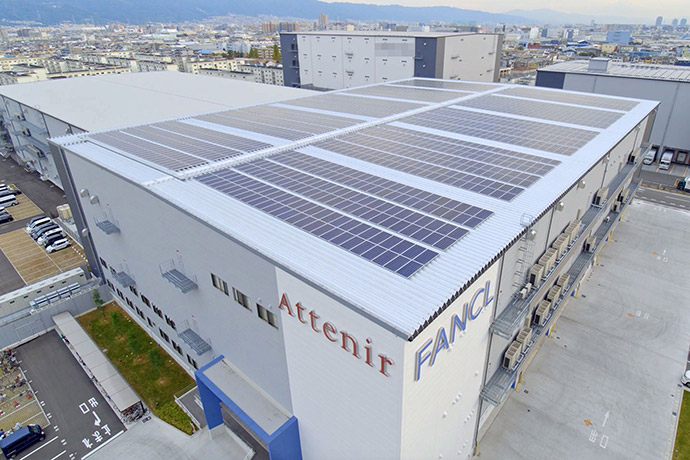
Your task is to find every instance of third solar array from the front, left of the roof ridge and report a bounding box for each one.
[282,94,424,118]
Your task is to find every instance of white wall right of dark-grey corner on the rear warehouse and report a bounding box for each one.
[437,34,500,82]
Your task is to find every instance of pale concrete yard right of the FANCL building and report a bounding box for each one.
[479,199,690,460]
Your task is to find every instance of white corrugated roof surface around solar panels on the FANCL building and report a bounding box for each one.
[53,79,657,337]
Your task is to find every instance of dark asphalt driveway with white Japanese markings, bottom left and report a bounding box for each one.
[16,331,125,460]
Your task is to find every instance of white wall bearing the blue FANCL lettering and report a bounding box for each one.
[401,263,498,460]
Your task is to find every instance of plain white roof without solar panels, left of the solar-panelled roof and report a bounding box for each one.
[0,71,310,131]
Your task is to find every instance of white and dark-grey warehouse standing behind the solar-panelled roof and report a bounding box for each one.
[280,31,503,89]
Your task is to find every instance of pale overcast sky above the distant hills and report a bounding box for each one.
[323,0,690,23]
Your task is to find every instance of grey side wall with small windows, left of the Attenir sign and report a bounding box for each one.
[61,152,291,410]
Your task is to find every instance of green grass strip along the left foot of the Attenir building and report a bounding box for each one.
[77,302,194,434]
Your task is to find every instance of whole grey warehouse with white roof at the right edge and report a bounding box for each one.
[536,58,690,165]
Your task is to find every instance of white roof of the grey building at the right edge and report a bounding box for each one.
[539,60,690,82]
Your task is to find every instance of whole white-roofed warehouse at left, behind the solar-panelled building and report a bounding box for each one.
[0,72,307,188]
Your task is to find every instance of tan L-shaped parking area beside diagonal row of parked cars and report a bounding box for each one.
[0,228,86,284]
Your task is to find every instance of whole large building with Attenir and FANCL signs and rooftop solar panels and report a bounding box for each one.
[52,79,657,459]
